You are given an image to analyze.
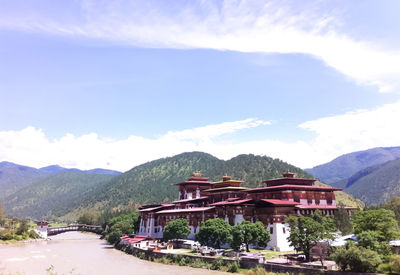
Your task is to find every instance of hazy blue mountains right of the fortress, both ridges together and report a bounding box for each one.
[306,147,400,205]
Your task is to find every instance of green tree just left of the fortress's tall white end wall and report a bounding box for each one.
[231,221,271,252]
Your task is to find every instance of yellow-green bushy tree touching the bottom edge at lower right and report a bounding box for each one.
[332,242,382,272]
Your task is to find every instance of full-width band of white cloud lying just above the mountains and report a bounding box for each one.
[0,101,400,171]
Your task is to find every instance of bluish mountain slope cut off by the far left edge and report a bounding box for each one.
[0,161,49,201]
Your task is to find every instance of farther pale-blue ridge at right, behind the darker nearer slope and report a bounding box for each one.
[305,147,400,187]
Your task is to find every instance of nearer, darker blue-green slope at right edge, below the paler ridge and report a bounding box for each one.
[341,159,400,205]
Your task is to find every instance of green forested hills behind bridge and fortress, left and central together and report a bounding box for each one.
[3,152,363,221]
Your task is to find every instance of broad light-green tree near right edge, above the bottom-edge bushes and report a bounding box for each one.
[352,209,399,242]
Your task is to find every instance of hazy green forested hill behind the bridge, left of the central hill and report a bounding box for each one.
[3,172,115,219]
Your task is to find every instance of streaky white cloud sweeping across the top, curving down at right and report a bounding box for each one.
[0,0,400,92]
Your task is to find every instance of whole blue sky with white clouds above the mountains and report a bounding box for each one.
[0,0,400,171]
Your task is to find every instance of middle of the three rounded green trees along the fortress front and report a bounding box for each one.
[196,218,232,248]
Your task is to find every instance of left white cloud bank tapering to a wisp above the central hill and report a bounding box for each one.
[0,119,270,171]
